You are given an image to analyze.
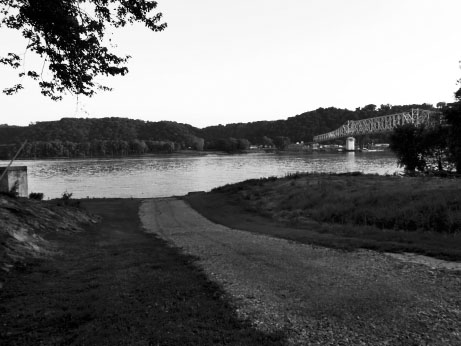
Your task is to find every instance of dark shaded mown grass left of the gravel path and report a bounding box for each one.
[0,200,282,345]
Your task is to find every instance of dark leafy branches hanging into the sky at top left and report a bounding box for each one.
[0,0,166,100]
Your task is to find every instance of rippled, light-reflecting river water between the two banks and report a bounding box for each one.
[0,152,400,198]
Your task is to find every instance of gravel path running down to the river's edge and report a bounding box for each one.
[140,198,461,345]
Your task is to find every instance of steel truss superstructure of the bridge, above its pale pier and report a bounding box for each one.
[314,109,441,143]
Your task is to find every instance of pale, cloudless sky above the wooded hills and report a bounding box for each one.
[0,0,461,128]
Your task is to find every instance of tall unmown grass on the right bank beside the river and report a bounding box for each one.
[232,173,461,233]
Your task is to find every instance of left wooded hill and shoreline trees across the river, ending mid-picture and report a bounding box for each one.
[0,118,204,159]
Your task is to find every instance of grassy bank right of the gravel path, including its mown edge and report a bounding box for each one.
[186,174,461,260]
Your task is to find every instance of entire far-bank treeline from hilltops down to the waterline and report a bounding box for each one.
[0,104,432,159]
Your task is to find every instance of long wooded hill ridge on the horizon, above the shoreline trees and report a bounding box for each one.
[0,104,434,150]
